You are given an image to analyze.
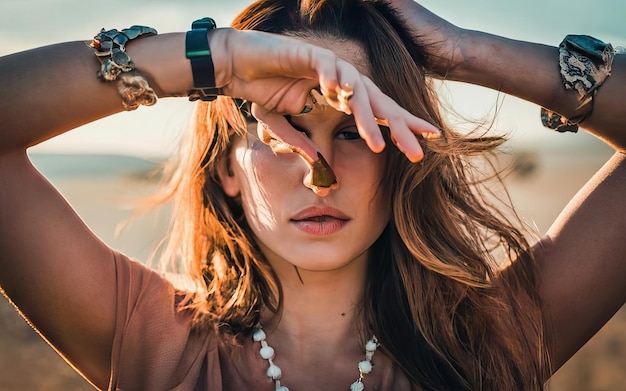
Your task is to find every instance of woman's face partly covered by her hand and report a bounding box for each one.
[217,40,390,271]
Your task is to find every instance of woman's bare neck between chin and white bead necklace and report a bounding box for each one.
[264,255,367,362]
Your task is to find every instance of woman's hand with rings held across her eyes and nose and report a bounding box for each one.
[211,29,440,161]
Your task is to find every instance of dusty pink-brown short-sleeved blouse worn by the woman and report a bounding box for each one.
[108,255,416,391]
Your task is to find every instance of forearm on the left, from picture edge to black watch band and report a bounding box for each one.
[0,33,192,153]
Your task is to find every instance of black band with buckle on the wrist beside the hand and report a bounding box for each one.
[185,17,220,101]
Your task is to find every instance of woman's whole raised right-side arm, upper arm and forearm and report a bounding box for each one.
[390,0,626,369]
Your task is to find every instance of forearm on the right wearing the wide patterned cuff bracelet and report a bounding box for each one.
[387,0,626,151]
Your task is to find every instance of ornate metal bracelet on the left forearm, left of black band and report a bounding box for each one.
[88,26,157,111]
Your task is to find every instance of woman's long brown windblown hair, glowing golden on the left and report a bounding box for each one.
[154,0,549,390]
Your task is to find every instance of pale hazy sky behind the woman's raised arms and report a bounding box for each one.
[0,0,626,157]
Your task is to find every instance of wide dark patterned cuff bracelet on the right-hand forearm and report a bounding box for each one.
[541,35,615,133]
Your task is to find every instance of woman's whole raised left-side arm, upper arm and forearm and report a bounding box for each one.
[0,29,202,389]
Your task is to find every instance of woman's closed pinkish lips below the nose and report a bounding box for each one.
[290,207,350,236]
